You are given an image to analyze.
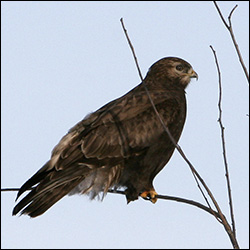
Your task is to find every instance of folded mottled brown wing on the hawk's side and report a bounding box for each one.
[57,88,181,161]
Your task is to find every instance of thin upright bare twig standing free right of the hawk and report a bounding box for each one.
[210,45,236,238]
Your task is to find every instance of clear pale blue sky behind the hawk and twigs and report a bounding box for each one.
[1,1,249,249]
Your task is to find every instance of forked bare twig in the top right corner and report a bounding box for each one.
[213,1,249,83]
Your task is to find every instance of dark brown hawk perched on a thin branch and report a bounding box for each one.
[13,57,198,217]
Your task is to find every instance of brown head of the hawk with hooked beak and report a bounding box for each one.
[146,57,198,88]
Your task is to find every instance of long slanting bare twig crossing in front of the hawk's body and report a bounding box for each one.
[120,18,239,248]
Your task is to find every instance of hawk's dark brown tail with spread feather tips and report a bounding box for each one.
[12,162,87,217]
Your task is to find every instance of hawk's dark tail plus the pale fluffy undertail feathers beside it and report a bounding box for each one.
[12,158,122,217]
